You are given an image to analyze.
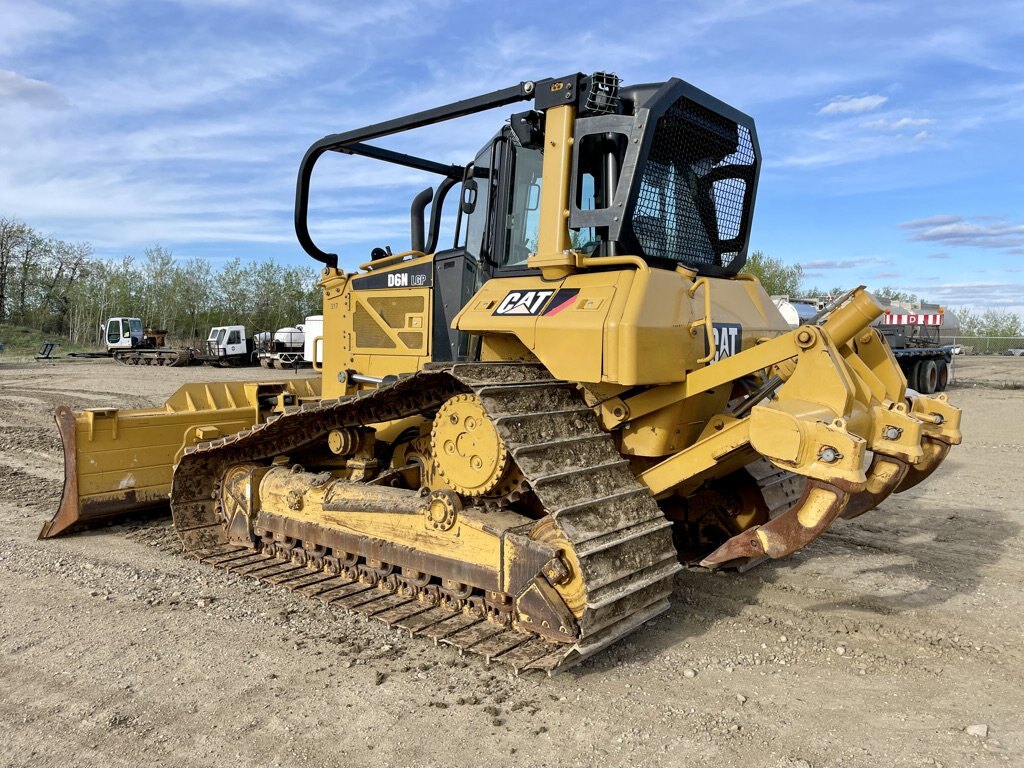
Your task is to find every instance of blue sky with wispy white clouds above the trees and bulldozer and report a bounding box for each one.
[0,0,1024,312]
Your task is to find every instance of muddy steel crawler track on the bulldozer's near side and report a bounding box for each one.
[171,364,681,673]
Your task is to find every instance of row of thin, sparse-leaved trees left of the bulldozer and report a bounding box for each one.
[0,218,322,344]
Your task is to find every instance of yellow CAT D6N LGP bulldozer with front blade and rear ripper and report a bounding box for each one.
[41,73,961,672]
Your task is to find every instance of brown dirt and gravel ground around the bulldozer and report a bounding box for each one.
[0,360,1024,768]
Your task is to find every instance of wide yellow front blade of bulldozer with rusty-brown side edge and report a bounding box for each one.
[39,379,319,539]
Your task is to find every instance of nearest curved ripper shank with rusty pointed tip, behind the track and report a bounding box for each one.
[700,479,851,569]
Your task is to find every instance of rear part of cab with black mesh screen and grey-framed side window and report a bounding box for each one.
[569,78,761,276]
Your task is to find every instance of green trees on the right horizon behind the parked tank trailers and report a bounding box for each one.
[743,251,1024,338]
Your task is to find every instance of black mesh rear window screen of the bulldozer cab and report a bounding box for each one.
[632,96,756,269]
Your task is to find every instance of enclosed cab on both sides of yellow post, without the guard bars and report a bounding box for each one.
[452,81,760,276]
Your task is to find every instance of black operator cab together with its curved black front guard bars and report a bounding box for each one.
[295,73,761,360]
